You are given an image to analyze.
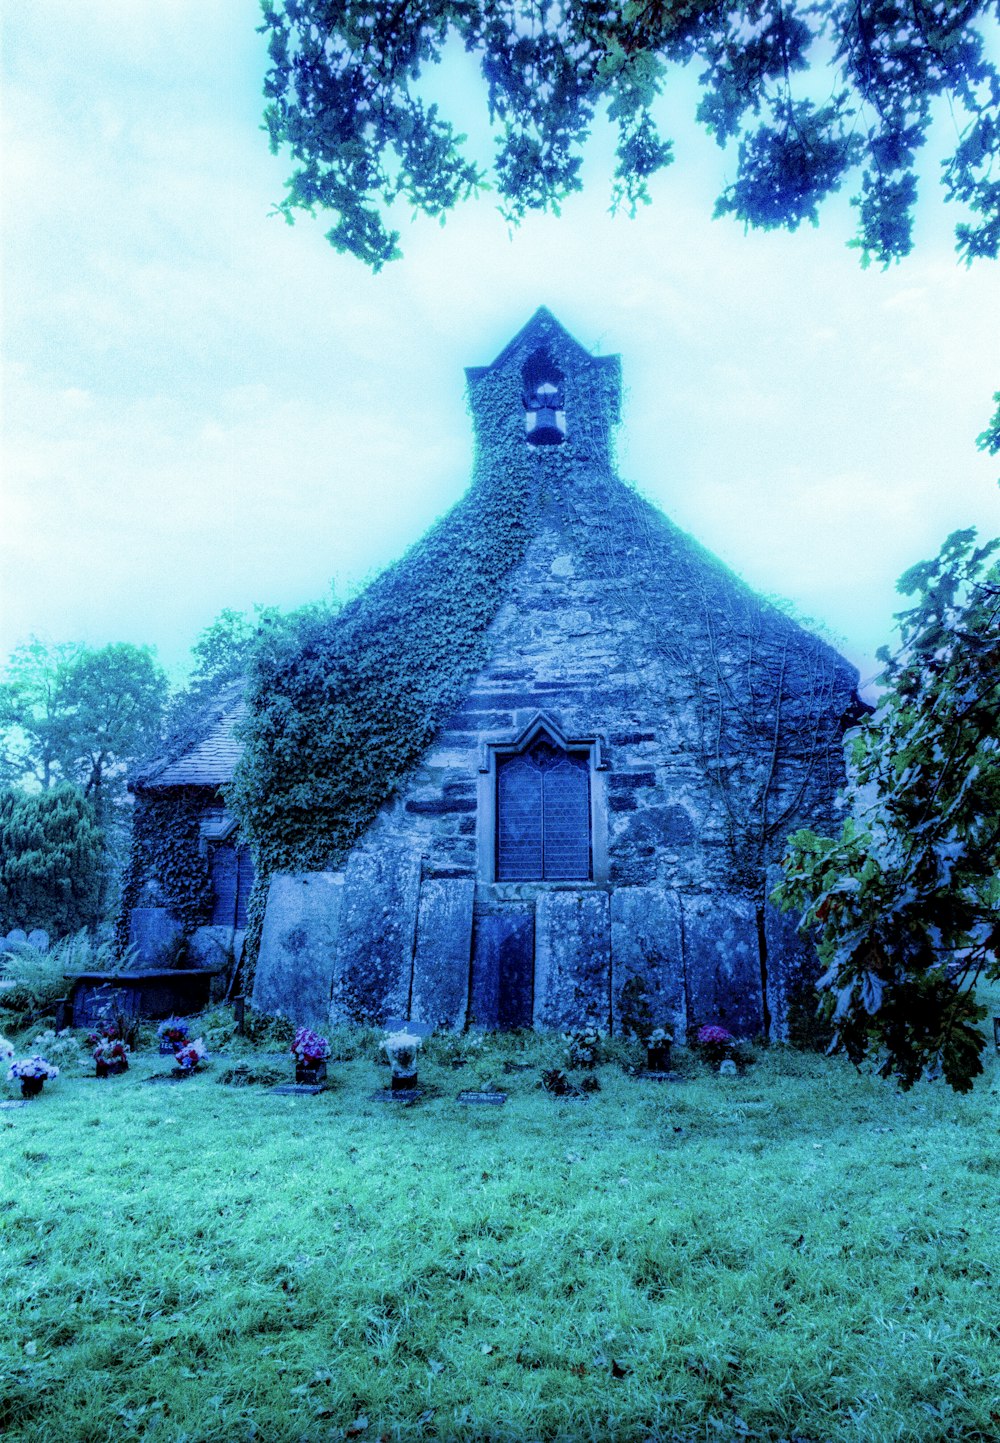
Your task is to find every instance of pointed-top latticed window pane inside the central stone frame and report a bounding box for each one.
[495,736,593,882]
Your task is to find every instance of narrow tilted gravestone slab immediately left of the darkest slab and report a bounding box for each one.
[410,879,476,1030]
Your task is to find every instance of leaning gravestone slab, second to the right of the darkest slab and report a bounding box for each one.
[610,887,687,1042]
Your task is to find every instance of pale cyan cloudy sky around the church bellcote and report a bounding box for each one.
[0,0,1000,698]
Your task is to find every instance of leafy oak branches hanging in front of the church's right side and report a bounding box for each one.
[775,531,1000,1091]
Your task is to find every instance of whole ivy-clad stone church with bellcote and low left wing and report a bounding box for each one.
[124,309,863,1039]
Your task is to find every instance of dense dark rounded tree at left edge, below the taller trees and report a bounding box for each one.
[0,782,104,937]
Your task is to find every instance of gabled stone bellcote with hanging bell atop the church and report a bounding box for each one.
[466,306,622,462]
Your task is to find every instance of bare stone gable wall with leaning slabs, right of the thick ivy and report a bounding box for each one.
[257,473,856,1036]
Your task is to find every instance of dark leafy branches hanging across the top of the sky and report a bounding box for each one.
[261,0,1000,270]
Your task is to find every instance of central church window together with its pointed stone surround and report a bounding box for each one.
[479,713,606,886]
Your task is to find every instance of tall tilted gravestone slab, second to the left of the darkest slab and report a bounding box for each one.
[330,838,420,1025]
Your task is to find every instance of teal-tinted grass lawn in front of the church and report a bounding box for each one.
[0,1027,1000,1443]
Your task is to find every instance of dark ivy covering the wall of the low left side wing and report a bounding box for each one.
[115,786,218,951]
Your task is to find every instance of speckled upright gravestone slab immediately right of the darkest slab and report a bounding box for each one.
[534,892,610,1030]
